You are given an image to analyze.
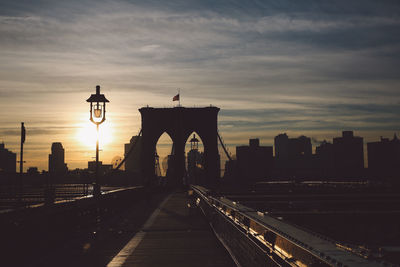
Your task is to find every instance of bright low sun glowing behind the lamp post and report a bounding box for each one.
[76,121,112,148]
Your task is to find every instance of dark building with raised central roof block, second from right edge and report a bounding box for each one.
[333,131,364,178]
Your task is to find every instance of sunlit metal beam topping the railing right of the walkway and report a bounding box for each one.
[192,186,376,266]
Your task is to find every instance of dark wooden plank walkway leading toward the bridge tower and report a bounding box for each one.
[108,193,236,267]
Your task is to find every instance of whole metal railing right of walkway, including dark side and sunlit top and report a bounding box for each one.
[192,186,380,266]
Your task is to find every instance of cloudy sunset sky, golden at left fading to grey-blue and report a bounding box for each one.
[0,0,400,170]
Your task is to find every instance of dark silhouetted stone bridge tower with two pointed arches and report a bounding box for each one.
[139,106,220,187]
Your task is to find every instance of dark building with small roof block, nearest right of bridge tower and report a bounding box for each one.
[236,139,273,183]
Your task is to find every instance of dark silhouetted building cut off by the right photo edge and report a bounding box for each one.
[367,135,400,178]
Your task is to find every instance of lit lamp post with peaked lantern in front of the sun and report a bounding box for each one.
[86,85,110,197]
